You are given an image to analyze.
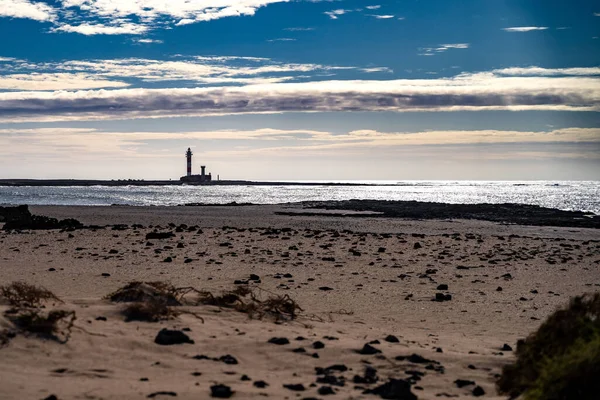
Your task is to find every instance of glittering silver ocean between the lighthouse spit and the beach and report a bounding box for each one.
[0,181,600,215]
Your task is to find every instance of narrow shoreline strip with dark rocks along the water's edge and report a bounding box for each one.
[0,200,600,229]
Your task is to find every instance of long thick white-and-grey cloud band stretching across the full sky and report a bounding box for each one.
[0,73,600,121]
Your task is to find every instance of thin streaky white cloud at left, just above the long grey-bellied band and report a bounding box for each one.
[0,54,358,90]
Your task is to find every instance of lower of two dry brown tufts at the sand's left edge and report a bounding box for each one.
[5,309,76,343]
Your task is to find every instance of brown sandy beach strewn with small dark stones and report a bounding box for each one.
[0,205,600,400]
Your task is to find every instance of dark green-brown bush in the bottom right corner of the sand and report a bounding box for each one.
[498,293,600,400]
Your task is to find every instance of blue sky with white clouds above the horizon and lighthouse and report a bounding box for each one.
[0,0,600,180]
